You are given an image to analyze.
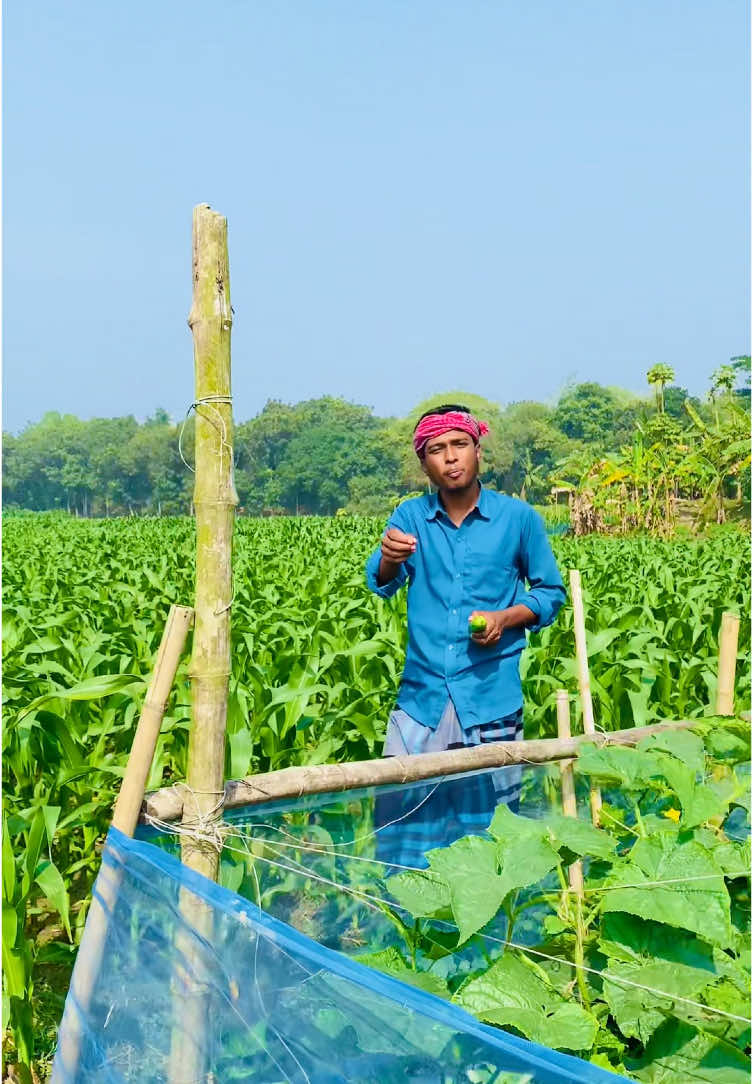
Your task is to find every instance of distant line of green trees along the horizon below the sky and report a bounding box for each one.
[3,358,750,516]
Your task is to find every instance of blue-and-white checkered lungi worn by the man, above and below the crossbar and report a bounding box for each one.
[374,700,523,869]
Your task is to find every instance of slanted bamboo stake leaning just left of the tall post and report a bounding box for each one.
[55,606,194,1081]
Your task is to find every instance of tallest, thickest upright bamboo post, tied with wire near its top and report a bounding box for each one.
[169,204,238,1084]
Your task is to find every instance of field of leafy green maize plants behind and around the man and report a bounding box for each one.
[3,515,751,1079]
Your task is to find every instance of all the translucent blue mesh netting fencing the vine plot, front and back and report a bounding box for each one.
[53,765,745,1084]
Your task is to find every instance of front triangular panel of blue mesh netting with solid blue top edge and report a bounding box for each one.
[53,815,614,1084]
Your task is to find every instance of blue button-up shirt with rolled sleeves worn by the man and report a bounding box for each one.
[366,487,566,730]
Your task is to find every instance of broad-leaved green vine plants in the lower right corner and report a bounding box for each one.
[374,720,750,1084]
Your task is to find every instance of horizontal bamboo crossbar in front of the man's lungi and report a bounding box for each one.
[142,719,700,822]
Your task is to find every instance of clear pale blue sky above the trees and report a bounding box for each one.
[3,0,750,431]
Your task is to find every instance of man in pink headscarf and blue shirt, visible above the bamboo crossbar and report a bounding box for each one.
[366,403,566,867]
